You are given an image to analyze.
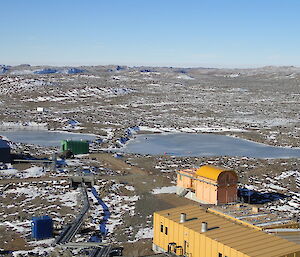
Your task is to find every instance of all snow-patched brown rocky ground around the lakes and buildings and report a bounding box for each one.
[0,65,300,256]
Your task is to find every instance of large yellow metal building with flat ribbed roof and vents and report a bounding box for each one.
[153,205,300,257]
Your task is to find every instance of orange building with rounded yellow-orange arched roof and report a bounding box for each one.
[177,165,238,205]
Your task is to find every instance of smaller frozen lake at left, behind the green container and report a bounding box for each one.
[0,130,96,146]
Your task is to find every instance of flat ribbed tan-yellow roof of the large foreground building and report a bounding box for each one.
[155,205,300,257]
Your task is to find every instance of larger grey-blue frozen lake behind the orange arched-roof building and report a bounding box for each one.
[121,133,300,158]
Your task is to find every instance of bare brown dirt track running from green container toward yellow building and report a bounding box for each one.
[90,154,195,257]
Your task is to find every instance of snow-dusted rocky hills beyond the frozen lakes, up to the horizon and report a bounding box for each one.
[0,66,300,146]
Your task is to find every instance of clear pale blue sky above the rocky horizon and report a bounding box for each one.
[0,0,300,67]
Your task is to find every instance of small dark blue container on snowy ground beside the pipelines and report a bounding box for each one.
[31,216,53,240]
